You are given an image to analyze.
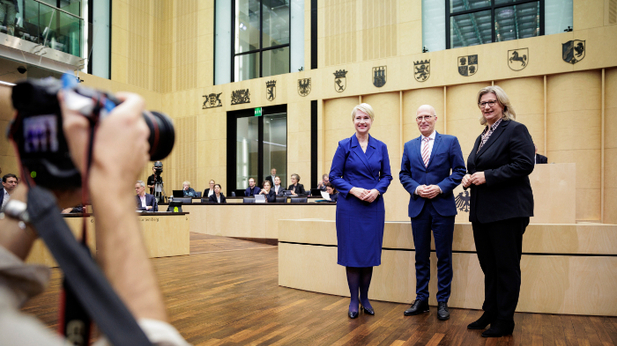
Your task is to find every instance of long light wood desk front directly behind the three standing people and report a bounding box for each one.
[278,220,617,316]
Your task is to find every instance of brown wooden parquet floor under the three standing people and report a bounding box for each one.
[20,234,617,345]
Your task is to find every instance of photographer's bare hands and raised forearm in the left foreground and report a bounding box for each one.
[59,93,167,321]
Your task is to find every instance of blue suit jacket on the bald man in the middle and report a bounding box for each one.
[399,133,465,217]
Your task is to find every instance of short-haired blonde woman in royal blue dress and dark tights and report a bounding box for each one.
[330,103,392,318]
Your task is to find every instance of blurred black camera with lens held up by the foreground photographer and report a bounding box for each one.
[8,74,175,189]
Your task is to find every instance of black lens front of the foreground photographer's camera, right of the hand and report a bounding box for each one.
[143,111,176,161]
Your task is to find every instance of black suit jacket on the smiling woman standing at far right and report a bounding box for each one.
[467,120,535,223]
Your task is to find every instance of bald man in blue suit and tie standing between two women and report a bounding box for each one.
[399,105,465,320]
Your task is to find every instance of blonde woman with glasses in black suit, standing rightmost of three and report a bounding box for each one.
[462,86,534,337]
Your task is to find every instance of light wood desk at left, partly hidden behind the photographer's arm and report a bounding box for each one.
[26,212,190,267]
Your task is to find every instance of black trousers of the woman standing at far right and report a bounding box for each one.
[472,217,529,322]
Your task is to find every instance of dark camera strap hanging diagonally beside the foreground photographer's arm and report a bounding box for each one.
[27,186,152,345]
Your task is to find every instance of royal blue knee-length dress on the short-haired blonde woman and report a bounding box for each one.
[330,134,392,267]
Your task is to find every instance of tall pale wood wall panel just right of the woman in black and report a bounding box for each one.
[547,70,602,221]
